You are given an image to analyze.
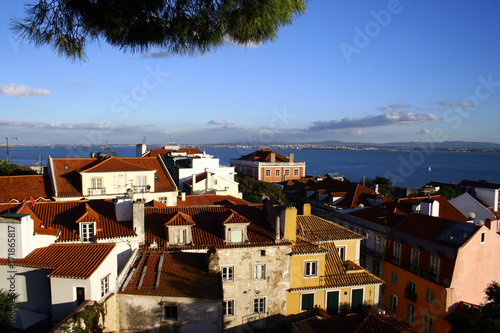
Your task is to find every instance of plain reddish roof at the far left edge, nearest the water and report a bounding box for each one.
[0,175,52,202]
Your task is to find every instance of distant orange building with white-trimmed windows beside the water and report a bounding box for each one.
[230,149,306,183]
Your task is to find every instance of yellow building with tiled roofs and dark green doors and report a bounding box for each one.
[284,205,383,315]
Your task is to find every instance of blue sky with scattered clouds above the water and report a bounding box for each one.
[0,0,500,144]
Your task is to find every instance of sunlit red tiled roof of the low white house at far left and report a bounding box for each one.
[0,243,115,279]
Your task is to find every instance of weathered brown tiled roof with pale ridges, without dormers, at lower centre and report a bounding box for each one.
[119,250,222,299]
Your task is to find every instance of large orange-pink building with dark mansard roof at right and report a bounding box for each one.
[384,213,500,332]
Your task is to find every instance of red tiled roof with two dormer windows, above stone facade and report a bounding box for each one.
[145,204,288,248]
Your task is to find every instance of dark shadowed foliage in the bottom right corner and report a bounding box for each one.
[450,281,500,333]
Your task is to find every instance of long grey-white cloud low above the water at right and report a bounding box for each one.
[308,111,441,131]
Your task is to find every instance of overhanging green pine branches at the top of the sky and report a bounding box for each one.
[12,0,307,61]
